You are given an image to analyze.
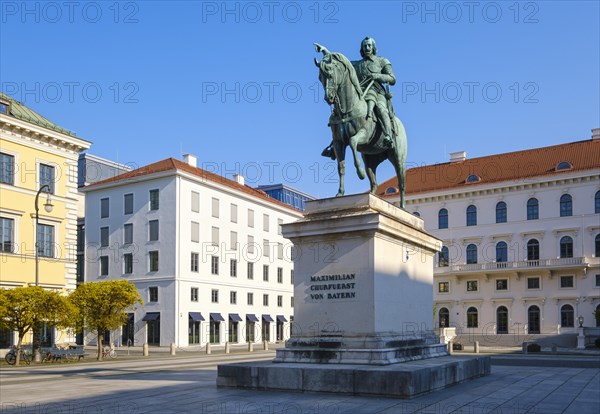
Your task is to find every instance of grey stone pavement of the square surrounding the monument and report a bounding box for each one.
[0,351,600,414]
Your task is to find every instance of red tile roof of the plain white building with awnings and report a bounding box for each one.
[85,158,302,213]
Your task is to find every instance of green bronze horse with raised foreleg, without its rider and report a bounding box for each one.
[315,44,407,208]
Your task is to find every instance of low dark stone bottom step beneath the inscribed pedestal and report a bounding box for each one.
[217,356,491,398]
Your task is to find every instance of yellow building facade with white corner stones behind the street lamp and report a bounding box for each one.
[0,93,91,348]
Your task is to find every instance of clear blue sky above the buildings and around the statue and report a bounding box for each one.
[0,0,600,197]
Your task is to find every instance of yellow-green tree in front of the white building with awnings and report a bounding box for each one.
[69,280,144,361]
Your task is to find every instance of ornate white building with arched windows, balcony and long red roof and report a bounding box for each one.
[380,130,600,344]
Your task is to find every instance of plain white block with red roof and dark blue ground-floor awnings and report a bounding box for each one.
[83,155,302,347]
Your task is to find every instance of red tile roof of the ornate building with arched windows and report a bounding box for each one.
[377,139,600,196]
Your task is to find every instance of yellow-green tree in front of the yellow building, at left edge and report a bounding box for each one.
[0,286,76,365]
